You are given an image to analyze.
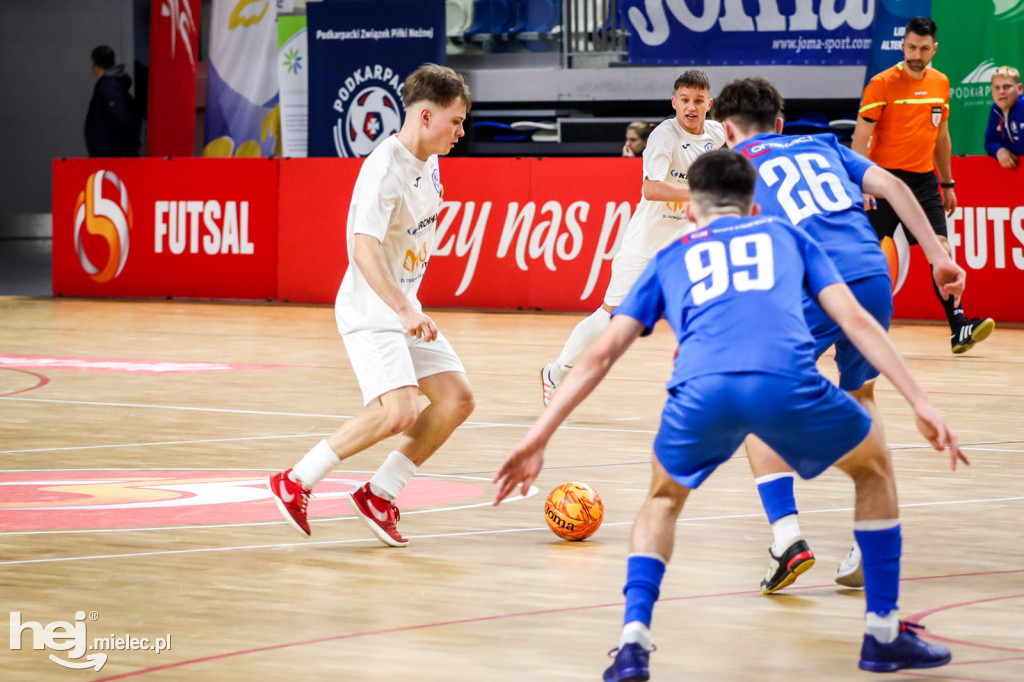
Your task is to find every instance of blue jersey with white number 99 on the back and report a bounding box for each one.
[614,216,843,389]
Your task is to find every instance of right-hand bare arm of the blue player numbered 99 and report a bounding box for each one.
[818,284,970,470]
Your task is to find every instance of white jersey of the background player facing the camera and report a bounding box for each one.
[620,117,725,259]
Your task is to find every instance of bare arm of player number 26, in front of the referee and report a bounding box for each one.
[861,166,967,297]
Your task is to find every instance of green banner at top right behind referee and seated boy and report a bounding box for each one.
[932,0,1024,154]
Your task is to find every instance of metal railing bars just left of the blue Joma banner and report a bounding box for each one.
[562,0,628,69]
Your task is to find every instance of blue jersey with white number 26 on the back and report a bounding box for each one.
[736,133,889,282]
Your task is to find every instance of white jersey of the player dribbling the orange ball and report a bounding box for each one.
[334,135,441,334]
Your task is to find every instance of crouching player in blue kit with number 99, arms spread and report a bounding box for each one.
[495,150,967,681]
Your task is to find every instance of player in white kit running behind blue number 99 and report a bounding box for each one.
[541,70,725,404]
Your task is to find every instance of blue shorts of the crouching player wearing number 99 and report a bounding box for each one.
[654,372,871,488]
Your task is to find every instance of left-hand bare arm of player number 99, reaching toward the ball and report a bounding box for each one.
[492,315,644,505]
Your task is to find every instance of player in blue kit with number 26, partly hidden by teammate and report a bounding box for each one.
[715,78,965,594]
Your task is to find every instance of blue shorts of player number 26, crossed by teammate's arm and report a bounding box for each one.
[804,274,893,391]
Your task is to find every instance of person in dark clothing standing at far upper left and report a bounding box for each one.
[85,45,139,157]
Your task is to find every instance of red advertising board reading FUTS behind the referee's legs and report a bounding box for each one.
[894,157,1024,323]
